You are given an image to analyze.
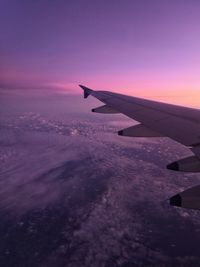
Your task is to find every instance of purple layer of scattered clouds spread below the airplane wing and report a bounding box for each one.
[0,91,199,267]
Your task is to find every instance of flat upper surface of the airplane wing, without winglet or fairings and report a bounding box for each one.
[91,91,200,146]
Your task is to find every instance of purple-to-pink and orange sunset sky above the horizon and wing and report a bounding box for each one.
[0,0,200,105]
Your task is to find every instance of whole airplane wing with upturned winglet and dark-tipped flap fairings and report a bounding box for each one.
[80,85,200,210]
